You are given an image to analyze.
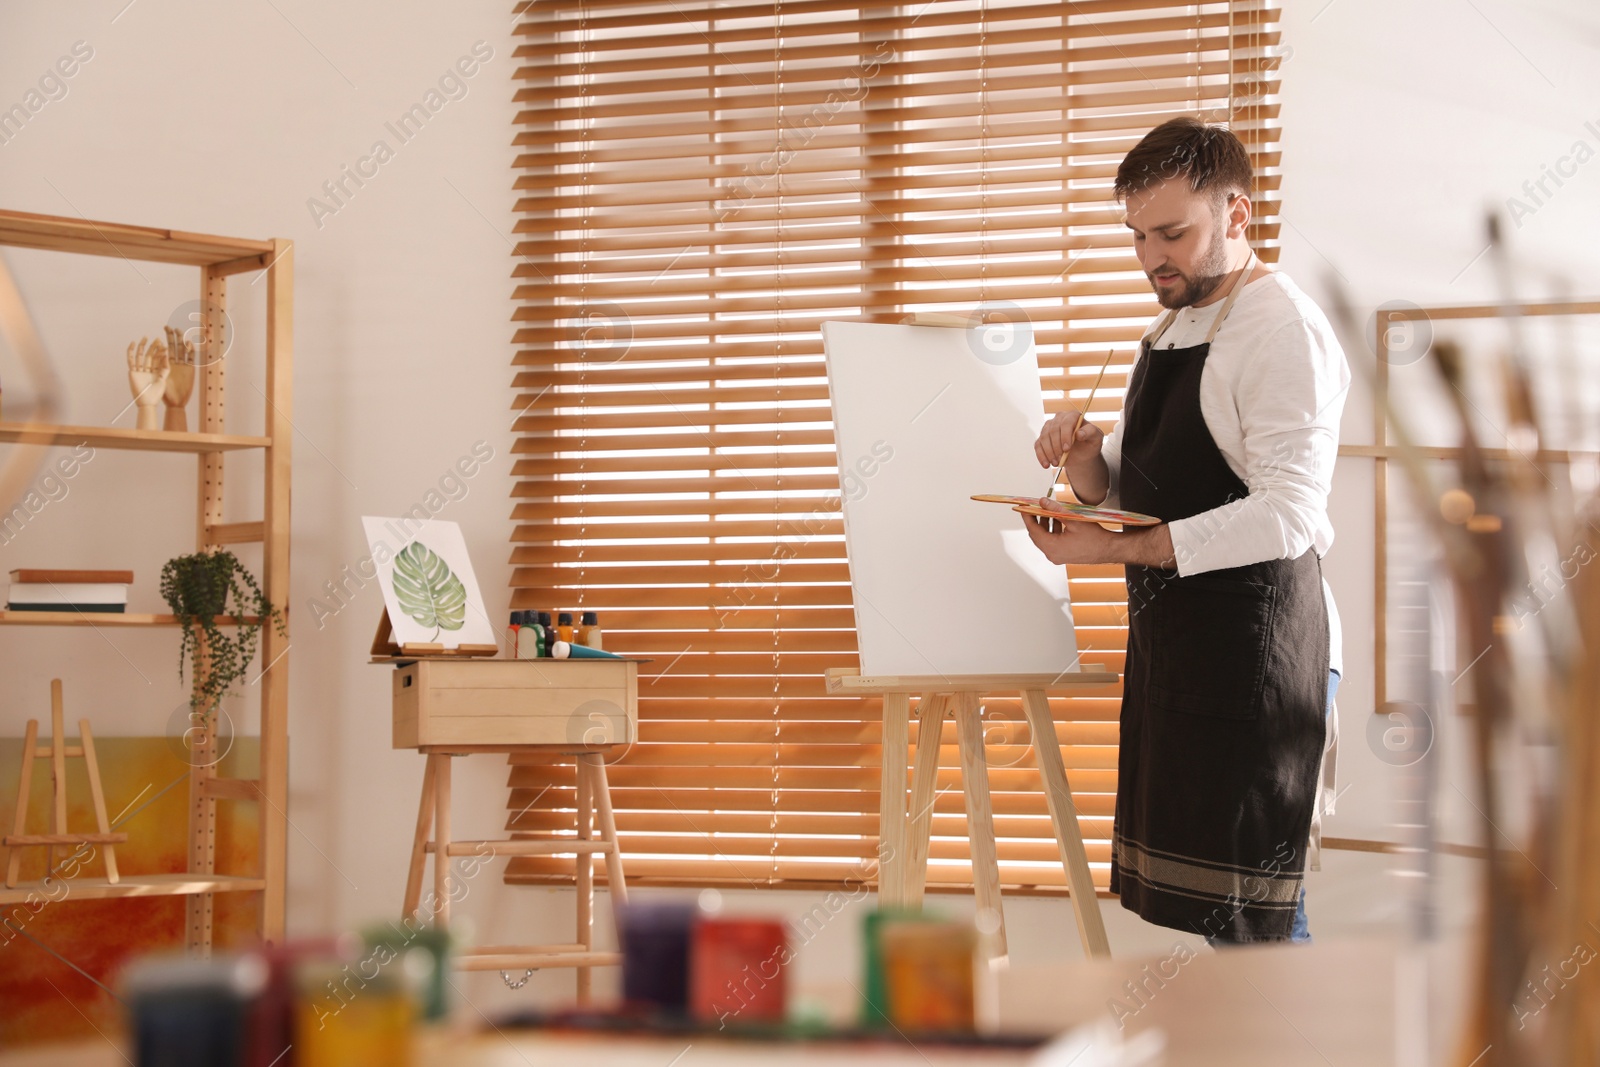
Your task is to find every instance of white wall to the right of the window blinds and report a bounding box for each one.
[1282,0,1600,841]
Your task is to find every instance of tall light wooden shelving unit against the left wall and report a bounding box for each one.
[0,211,294,955]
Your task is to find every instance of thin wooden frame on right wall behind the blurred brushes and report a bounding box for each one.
[1339,301,1600,715]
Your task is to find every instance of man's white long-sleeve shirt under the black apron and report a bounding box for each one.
[1102,272,1350,673]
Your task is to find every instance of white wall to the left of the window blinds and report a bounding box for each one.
[0,0,514,953]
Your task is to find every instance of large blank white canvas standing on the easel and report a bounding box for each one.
[822,322,1078,675]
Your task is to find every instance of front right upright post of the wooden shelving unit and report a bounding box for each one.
[259,240,294,944]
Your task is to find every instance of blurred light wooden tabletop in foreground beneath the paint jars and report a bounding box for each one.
[0,936,1464,1067]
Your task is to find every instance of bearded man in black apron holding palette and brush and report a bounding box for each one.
[1027,118,1350,944]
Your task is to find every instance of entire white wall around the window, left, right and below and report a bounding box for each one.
[0,0,1600,1023]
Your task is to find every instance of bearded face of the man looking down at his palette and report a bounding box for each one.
[1126,178,1227,307]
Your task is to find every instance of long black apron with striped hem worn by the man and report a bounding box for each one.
[1110,259,1328,941]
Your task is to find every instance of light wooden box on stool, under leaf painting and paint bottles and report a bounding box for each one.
[394,659,638,749]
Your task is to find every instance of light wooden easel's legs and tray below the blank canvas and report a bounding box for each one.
[827,667,1117,958]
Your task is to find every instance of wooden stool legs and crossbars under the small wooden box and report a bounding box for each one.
[402,744,627,1005]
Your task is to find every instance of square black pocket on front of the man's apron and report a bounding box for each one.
[1149,577,1277,720]
